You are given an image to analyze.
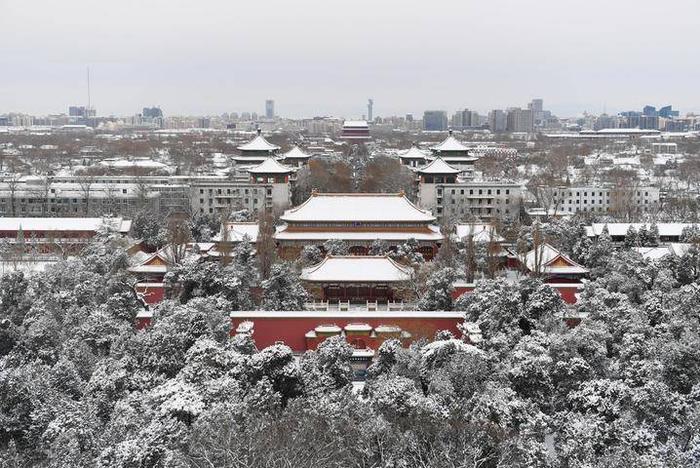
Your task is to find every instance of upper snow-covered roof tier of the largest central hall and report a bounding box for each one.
[280,193,435,223]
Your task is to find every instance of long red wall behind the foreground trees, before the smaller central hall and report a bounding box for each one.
[231,312,464,353]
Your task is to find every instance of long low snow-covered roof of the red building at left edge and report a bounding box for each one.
[0,217,131,234]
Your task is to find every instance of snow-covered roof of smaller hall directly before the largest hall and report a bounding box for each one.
[301,255,413,283]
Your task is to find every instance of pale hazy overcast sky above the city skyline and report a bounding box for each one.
[0,0,700,117]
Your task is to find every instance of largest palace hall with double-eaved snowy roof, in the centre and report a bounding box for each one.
[274,191,444,260]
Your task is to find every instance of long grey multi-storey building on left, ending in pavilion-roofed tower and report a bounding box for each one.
[0,168,292,217]
